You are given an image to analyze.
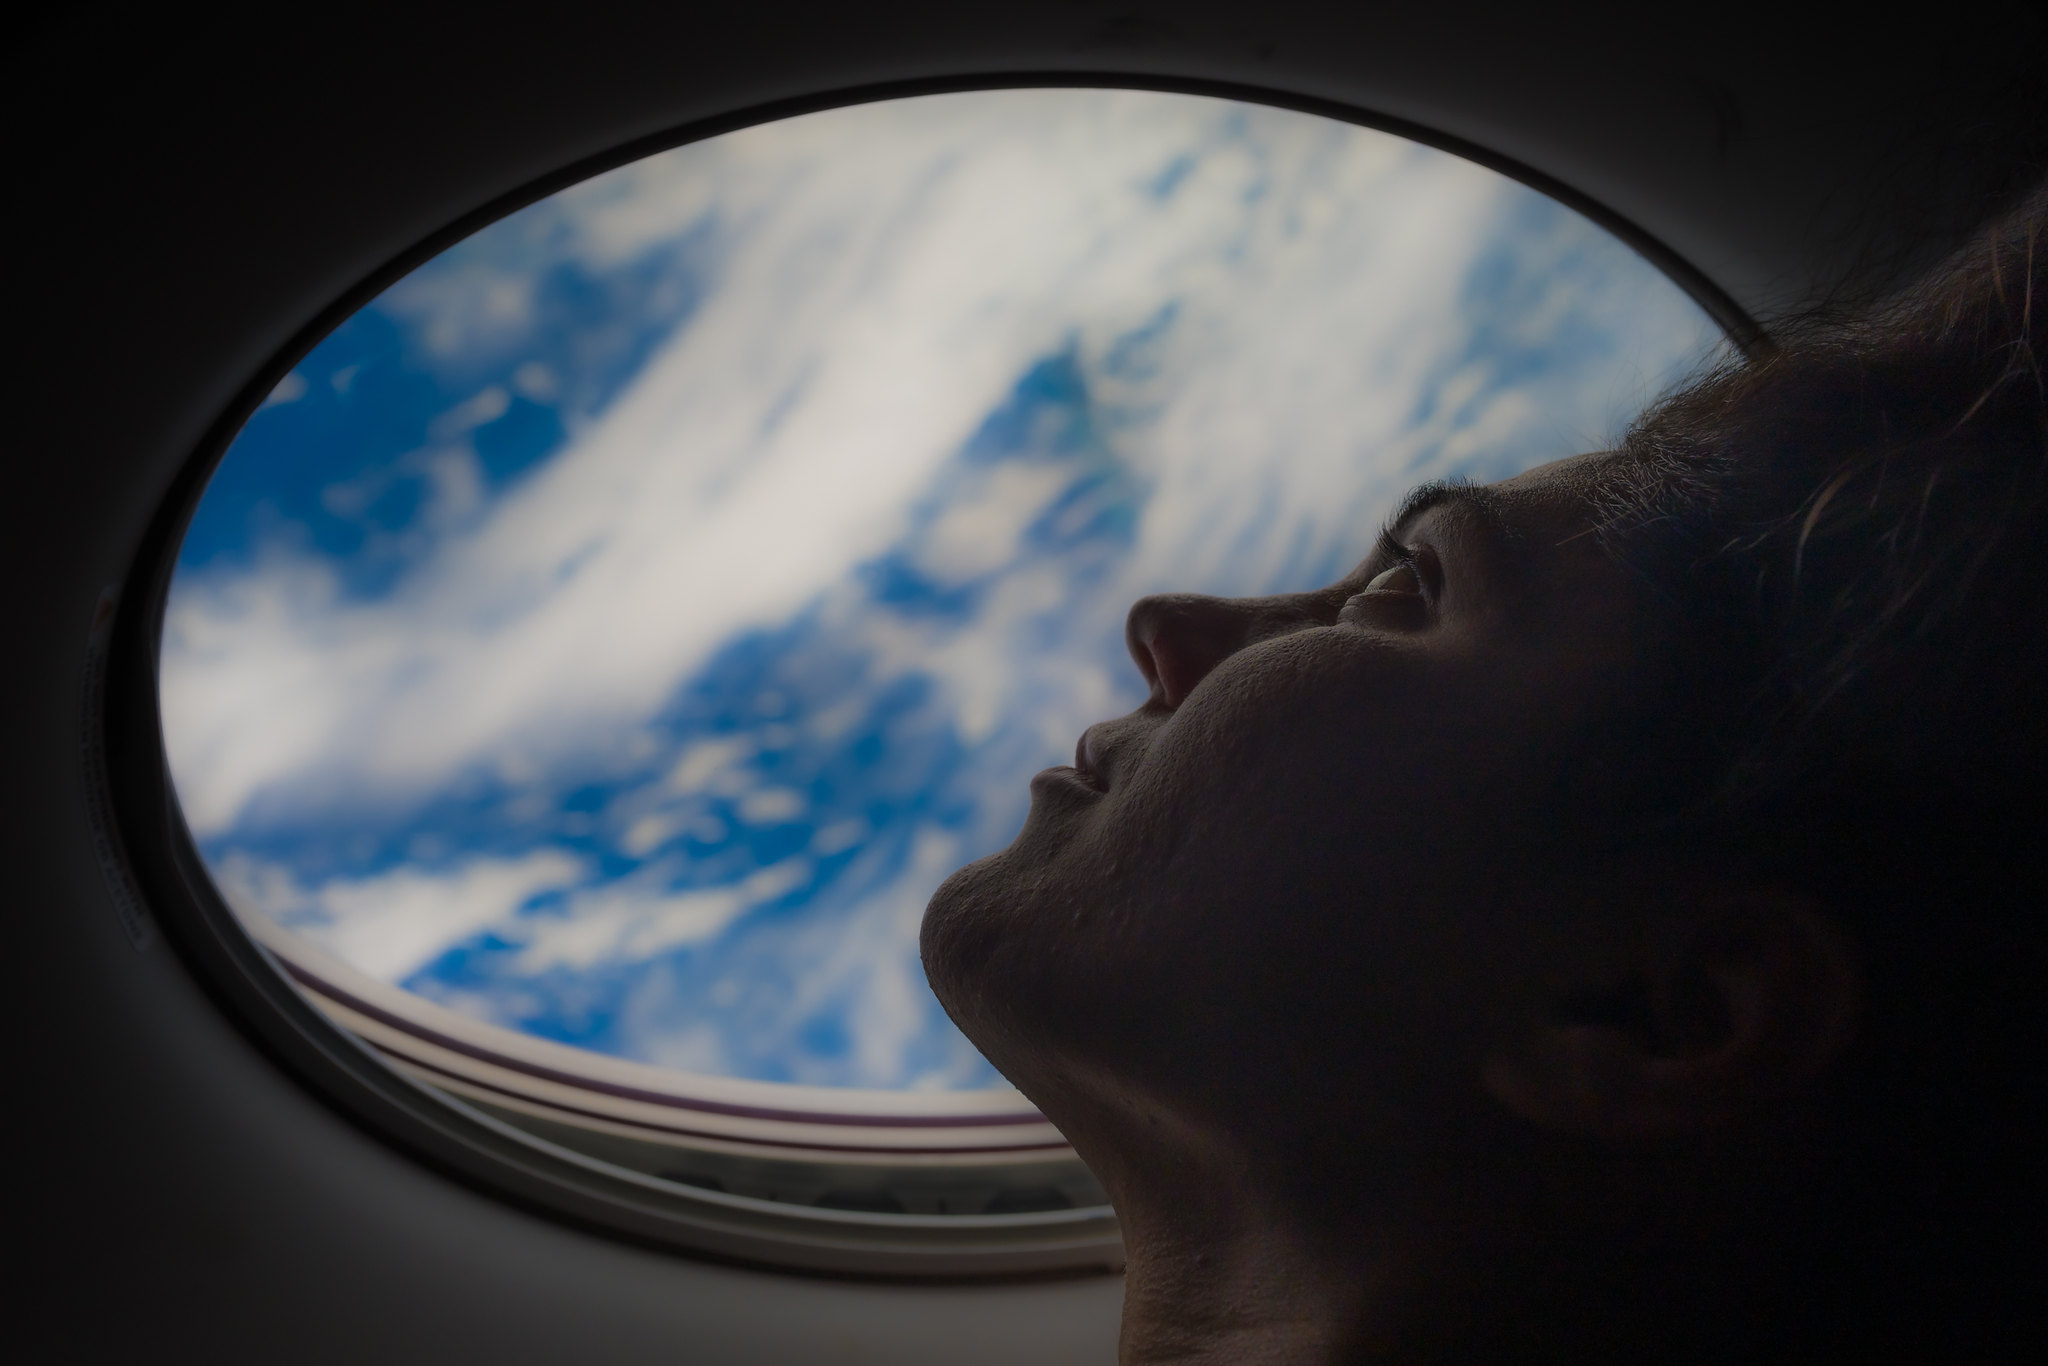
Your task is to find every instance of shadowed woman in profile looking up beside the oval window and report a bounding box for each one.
[922,193,2048,1362]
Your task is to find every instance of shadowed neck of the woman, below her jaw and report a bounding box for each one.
[1085,1126,1745,1366]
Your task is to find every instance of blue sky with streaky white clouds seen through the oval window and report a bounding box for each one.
[162,90,1716,1087]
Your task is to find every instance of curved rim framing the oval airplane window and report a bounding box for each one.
[99,72,1767,1280]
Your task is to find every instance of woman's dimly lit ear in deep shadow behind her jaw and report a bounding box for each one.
[1483,891,1858,1143]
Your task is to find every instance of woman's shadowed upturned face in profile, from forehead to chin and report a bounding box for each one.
[924,455,1688,1151]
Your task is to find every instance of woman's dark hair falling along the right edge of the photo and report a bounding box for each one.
[1602,186,2048,1360]
